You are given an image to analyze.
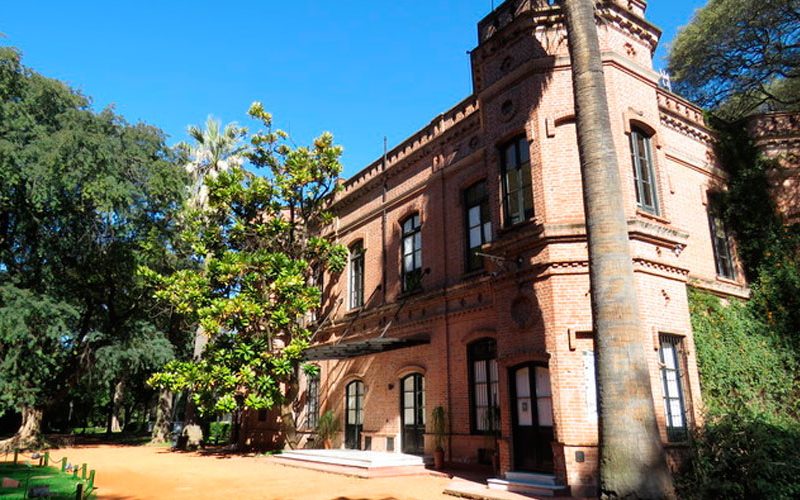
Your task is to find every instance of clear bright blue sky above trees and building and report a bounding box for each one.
[0,0,705,175]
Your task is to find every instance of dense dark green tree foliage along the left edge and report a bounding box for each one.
[0,47,187,430]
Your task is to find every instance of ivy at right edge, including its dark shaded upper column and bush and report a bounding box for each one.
[678,112,800,498]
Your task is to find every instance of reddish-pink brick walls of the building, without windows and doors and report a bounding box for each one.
[241,1,747,494]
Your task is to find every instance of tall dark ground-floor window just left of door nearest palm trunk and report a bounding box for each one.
[468,339,500,433]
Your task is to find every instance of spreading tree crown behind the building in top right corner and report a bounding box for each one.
[669,0,800,119]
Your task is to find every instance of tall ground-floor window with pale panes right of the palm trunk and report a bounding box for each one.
[659,334,688,441]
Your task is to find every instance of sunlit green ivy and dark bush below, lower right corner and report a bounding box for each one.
[679,240,800,498]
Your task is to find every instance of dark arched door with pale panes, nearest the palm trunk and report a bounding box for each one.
[509,363,553,473]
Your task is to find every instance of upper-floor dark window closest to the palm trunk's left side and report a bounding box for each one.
[501,136,533,226]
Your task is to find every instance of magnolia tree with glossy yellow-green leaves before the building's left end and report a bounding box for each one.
[144,103,347,448]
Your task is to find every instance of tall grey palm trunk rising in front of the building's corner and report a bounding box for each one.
[559,0,675,498]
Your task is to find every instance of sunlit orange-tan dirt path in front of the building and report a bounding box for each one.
[52,445,453,500]
